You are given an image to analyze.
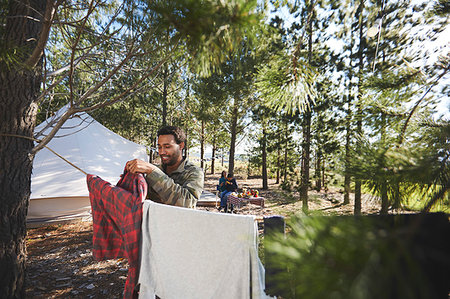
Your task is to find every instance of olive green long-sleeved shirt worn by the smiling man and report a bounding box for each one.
[145,159,204,208]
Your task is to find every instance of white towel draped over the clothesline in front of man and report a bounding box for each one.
[139,201,266,299]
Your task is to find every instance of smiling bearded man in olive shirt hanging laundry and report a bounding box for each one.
[126,126,204,208]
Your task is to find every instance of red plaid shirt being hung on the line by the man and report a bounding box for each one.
[87,173,147,298]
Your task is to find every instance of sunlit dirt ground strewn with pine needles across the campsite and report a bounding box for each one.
[26,174,380,299]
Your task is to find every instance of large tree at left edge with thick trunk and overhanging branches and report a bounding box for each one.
[0,0,258,298]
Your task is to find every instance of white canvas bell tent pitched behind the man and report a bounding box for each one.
[27,107,148,223]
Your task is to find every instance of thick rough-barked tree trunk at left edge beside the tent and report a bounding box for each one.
[0,1,46,298]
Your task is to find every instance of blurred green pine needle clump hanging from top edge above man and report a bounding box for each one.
[149,0,261,75]
